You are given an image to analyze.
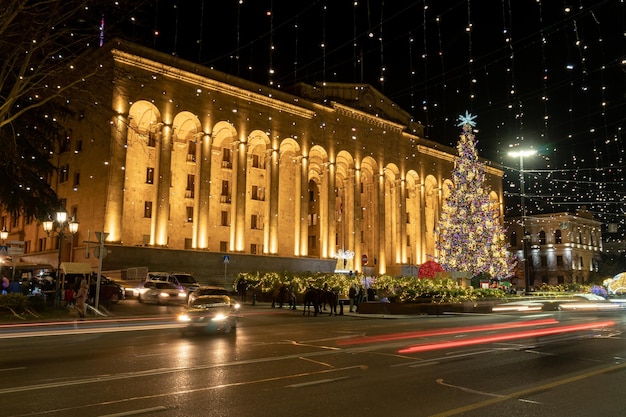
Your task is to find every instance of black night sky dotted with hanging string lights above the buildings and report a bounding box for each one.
[100,0,626,239]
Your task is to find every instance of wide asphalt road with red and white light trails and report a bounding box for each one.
[0,300,626,417]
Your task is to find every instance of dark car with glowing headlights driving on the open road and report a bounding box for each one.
[178,294,240,334]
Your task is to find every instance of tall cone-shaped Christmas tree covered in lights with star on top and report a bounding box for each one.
[437,112,511,279]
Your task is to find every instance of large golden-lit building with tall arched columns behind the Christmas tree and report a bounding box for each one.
[3,41,503,274]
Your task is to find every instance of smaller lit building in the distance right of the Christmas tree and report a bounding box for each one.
[505,209,602,288]
